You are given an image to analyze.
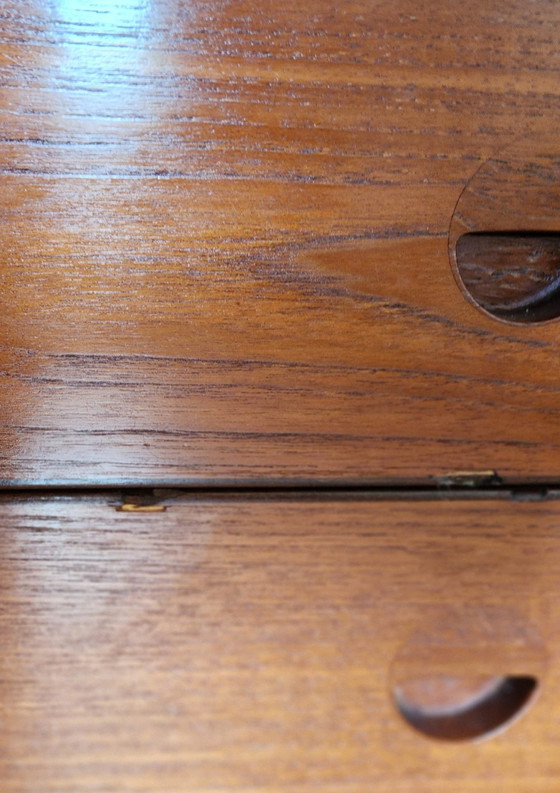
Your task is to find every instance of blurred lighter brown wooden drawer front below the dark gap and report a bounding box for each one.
[0,495,560,793]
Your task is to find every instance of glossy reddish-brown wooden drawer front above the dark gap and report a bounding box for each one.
[0,0,560,486]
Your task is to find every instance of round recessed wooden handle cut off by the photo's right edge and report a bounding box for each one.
[449,135,560,324]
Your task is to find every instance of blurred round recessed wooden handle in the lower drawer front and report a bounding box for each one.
[390,606,546,741]
